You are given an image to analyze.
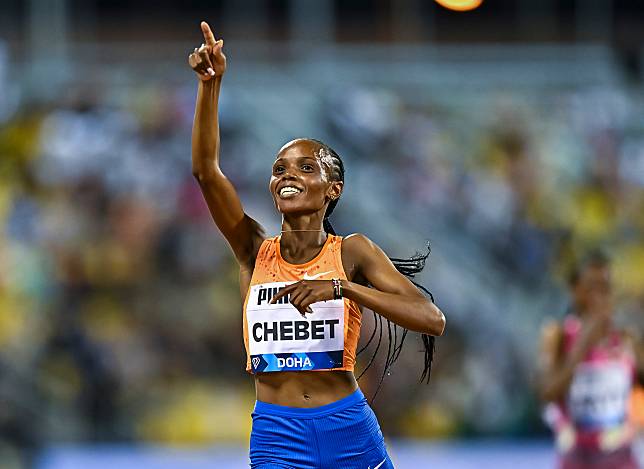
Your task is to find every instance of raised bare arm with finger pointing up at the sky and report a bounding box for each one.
[188,22,264,266]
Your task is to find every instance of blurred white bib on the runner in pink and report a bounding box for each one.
[568,362,632,429]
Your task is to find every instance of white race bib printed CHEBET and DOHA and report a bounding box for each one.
[246,282,344,373]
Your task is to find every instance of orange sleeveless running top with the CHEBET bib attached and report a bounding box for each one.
[243,235,362,373]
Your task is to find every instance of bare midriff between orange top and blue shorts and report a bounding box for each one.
[255,371,358,408]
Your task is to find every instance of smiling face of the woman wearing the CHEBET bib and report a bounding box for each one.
[269,139,342,218]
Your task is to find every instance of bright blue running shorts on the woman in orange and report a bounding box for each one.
[250,389,394,469]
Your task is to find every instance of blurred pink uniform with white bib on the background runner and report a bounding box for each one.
[546,315,637,469]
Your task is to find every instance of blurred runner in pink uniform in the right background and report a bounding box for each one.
[541,253,642,469]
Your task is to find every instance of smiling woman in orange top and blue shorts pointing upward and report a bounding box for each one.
[189,22,445,469]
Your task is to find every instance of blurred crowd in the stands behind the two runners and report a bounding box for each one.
[0,0,644,468]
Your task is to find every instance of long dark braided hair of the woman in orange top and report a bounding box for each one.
[309,139,435,399]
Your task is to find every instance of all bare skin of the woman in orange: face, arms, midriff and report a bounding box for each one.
[188,22,445,407]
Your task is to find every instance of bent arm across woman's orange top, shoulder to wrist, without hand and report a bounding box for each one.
[342,234,445,336]
